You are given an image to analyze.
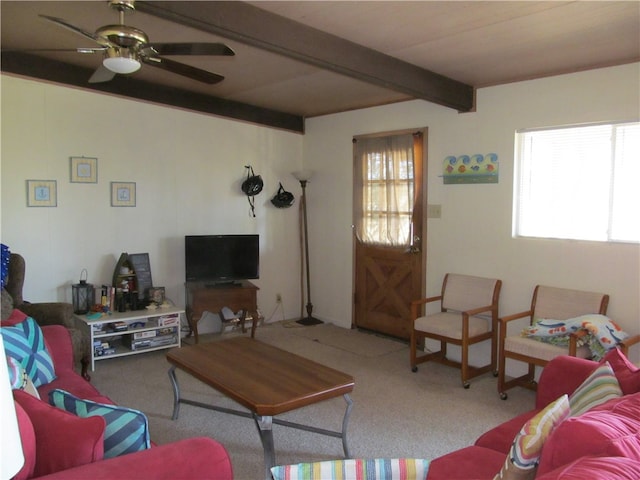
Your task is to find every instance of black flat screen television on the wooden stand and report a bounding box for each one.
[184,234,260,285]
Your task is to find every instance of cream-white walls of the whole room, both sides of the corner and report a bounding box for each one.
[0,64,640,364]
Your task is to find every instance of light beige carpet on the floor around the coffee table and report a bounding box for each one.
[87,323,534,480]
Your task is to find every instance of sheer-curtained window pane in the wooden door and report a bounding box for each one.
[355,134,421,246]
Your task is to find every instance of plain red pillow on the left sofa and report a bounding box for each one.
[13,390,105,477]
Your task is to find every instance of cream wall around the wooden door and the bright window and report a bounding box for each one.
[304,64,640,364]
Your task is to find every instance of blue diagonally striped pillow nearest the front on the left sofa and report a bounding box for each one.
[49,389,151,458]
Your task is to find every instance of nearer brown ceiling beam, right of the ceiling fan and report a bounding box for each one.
[136,1,474,112]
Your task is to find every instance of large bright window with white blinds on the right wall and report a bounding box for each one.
[514,122,640,242]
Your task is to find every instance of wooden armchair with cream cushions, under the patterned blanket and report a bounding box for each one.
[498,285,609,400]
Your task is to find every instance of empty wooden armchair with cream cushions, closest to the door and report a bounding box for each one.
[410,273,502,388]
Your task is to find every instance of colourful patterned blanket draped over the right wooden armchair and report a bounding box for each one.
[522,314,629,361]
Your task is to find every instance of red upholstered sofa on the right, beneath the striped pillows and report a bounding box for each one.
[427,349,640,480]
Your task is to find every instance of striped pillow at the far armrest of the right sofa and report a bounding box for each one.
[569,362,622,417]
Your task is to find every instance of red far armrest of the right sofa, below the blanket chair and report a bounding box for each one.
[536,355,598,409]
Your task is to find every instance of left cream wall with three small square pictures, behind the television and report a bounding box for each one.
[1,75,303,331]
